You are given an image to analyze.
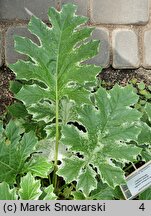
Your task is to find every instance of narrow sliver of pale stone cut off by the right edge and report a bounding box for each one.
[143,30,151,68]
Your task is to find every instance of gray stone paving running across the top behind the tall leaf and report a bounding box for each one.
[0,0,151,69]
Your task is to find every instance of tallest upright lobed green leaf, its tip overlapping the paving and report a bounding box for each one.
[9,4,101,123]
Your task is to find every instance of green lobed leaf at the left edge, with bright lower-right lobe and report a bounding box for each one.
[0,121,53,183]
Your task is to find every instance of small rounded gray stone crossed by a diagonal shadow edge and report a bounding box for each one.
[112,29,140,69]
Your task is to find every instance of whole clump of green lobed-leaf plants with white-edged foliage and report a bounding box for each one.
[0,4,151,200]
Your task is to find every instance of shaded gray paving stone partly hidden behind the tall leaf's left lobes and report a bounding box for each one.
[5,26,38,65]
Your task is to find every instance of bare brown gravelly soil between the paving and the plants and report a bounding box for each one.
[0,66,151,115]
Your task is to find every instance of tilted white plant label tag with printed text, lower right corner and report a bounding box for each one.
[120,161,151,200]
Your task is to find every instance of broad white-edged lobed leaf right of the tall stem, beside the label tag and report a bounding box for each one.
[57,85,141,196]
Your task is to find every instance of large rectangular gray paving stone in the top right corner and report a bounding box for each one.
[92,0,149,24]
